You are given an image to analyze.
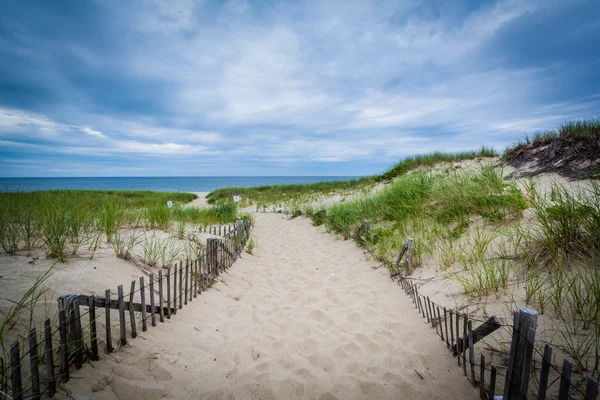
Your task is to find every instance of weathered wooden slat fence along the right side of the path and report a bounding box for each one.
[393,239,598,400]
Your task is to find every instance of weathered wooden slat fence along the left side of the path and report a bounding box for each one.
[0,221,251,400]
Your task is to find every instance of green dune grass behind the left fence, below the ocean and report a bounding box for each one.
[0,190,239,262]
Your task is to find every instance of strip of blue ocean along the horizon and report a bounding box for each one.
[0,176,360,192]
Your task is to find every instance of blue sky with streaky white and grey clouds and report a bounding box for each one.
[0,0,600,177]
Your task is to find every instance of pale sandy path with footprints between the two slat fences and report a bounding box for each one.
[63,214,477,400]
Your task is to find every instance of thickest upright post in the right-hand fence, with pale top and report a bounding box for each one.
[503,307,538,400]
